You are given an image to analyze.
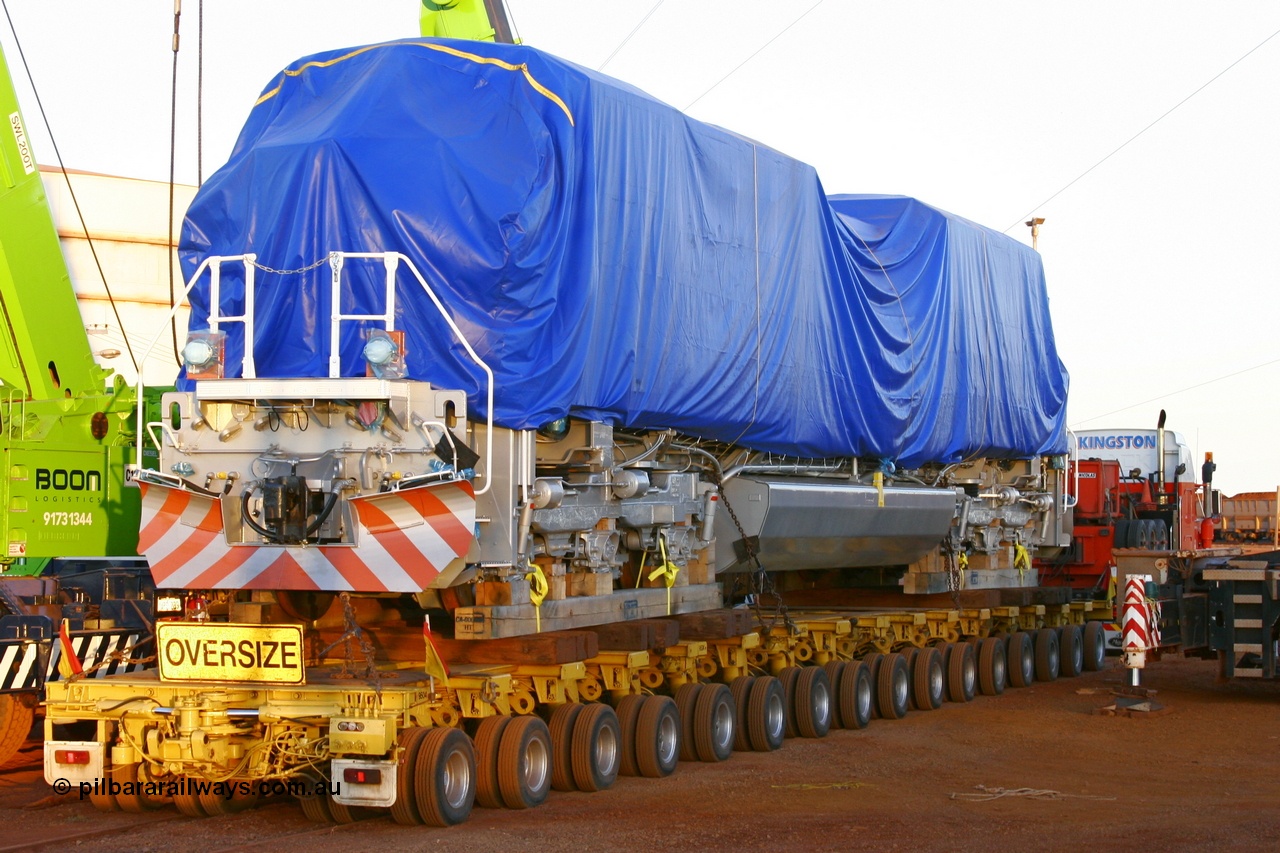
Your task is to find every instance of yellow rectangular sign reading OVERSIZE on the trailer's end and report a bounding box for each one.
[156,622,306,684]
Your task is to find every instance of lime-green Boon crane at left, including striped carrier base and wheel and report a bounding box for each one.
[0,44,159,766]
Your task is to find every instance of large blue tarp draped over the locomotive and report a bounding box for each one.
[180,40,1068,466]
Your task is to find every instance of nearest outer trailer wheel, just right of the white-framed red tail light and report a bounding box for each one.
[413,717,478,826]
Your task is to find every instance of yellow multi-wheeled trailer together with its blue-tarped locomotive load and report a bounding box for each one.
[45,31,1102,825]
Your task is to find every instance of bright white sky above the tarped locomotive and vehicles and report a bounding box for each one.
[0,0,1280,494]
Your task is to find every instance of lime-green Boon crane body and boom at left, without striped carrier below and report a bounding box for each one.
[0,46,149,574]
